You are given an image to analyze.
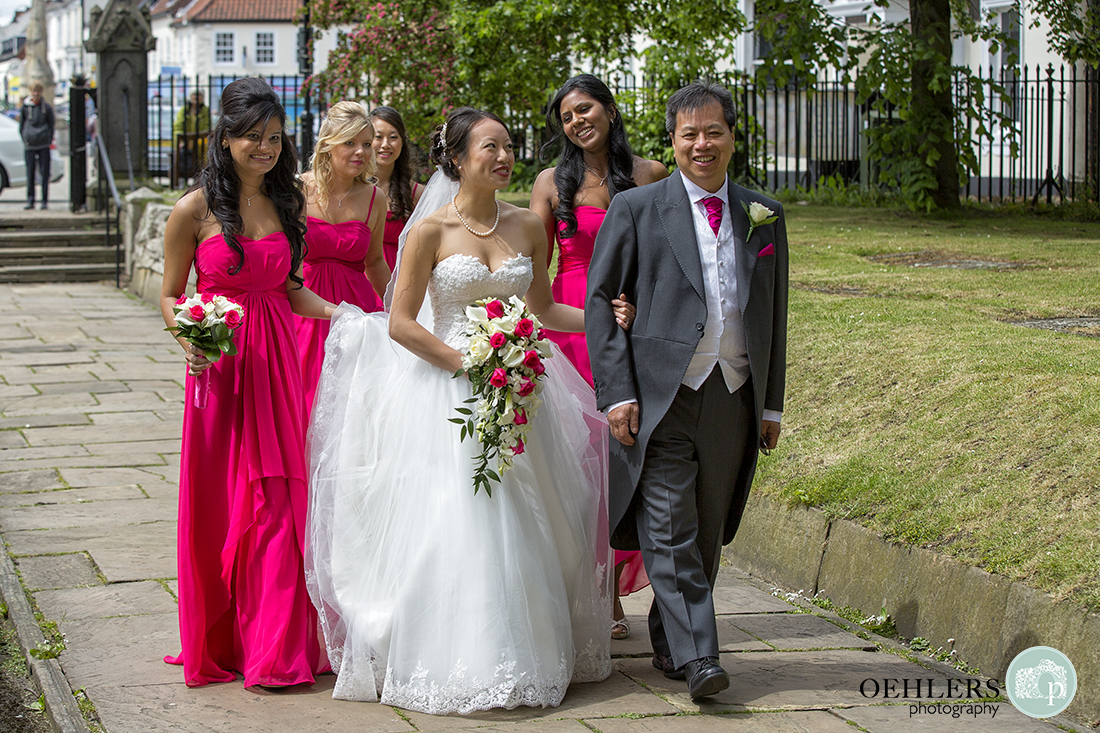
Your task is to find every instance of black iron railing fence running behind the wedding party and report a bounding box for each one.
[147,66,1100,201]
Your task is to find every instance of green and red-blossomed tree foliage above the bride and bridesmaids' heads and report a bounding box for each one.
[311,0,745,160]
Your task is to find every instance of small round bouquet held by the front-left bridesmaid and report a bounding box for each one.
[164,293,244,407]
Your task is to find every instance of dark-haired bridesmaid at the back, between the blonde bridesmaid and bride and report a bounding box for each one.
[371,107,424,271]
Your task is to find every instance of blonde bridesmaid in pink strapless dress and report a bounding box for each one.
[294,101,389,413]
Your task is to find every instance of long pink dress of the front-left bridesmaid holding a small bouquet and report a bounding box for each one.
[165,232,328,687]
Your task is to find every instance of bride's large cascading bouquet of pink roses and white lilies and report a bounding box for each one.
[450,295,550,496]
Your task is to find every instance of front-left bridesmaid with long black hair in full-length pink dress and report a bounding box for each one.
[161,78,336,687]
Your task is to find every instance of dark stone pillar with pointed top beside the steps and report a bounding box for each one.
[84,0,156,188]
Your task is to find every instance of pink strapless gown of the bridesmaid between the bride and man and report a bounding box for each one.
[547,206,649,595]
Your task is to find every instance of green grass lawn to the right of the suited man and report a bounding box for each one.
[756,205,1100,609]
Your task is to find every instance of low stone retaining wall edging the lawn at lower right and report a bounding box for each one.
[724,492,1100,723]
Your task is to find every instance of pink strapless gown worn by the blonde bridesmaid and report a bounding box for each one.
[294,211,382,407]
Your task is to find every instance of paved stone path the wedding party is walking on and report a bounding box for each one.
[0,284,1082,733]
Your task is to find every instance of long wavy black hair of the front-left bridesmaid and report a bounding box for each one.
[195,77,306,286]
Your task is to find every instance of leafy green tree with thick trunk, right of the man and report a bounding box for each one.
[754,0,1016,210]
